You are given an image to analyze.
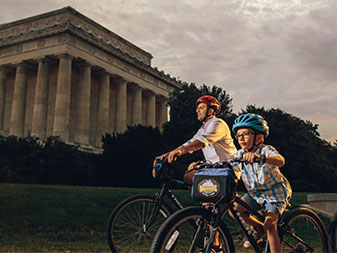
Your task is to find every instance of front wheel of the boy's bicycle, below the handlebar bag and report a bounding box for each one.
[151,207,234,253]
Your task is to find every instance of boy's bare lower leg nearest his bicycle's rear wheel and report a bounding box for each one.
[263,210,282,253]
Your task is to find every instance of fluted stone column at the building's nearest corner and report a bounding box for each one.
[53,55,72,141]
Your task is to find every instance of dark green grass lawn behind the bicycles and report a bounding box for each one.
[0,184,329,252]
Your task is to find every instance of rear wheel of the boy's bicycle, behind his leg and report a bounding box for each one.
[279,207,328,252]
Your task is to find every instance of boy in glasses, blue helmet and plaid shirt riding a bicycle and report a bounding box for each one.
[232,113,292,252]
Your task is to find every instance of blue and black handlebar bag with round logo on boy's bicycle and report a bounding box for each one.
[191,168,236,202]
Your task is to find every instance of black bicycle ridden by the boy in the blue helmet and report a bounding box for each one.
[151,160,328,252]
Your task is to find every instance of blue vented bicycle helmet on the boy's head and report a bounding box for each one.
[232,113,269,137]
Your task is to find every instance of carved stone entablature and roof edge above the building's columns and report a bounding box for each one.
[0,8,179,93]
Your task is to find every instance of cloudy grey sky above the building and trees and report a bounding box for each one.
[0,0,337,143]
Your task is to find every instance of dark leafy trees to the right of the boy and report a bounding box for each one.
[242,105,337,192]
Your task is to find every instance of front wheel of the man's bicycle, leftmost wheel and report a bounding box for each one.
[107,195,172,252]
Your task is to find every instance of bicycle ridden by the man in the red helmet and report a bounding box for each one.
[107,157,184,252]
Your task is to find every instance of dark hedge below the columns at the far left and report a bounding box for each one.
[0,136,95,185]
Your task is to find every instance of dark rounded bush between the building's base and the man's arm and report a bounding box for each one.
[96,125,166,187]
